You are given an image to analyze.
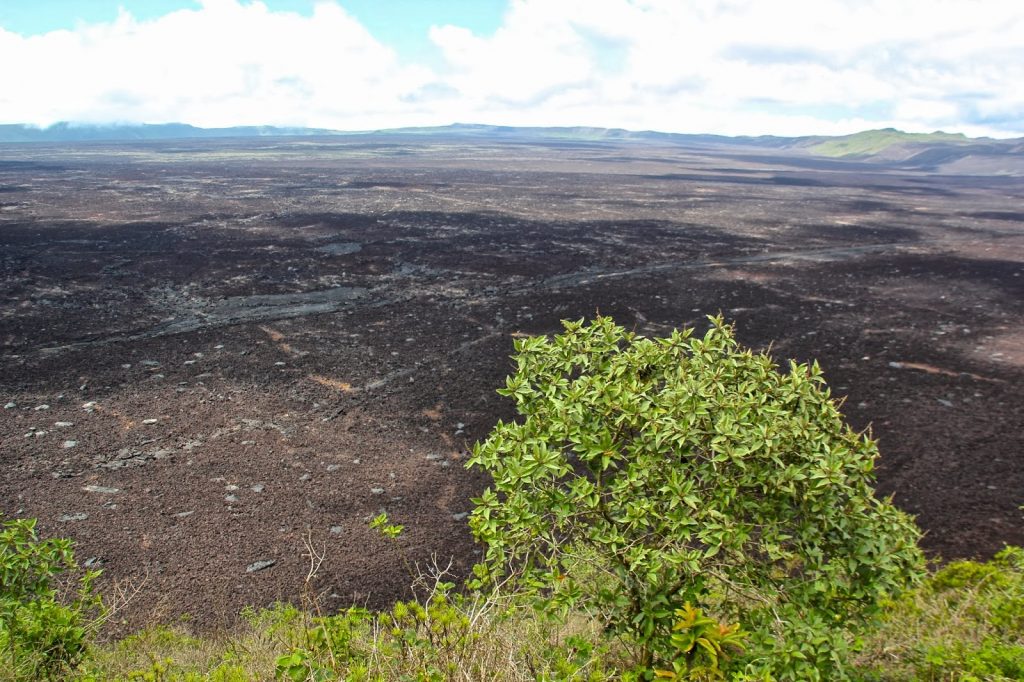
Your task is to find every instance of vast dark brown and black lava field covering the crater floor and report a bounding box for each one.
[0,135,1024,625]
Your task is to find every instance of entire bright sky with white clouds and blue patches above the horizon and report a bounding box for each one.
[0,0,1024,137]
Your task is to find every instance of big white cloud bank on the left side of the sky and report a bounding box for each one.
[0,0,431,127]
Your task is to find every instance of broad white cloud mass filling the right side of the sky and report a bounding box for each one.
[431,0,1024,136]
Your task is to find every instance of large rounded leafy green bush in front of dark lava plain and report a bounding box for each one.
[469,317,923,679]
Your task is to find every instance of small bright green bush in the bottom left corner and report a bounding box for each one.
[0,512,100,680]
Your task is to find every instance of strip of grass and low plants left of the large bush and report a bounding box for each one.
[66,597,626,682]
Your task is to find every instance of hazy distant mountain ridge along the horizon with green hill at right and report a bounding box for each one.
[0,123,1024,175]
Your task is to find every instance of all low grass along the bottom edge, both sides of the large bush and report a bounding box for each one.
[0,548,1024,682]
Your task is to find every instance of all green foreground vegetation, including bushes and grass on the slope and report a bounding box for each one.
[0,318,1024,682]
